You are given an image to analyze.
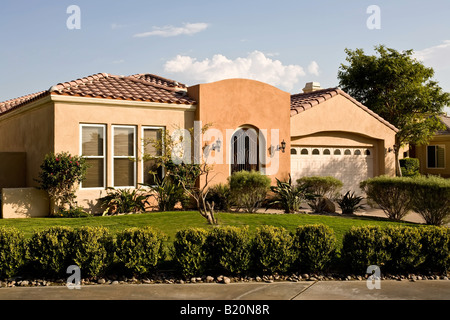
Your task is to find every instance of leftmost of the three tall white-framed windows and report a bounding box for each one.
[80,124,106,189]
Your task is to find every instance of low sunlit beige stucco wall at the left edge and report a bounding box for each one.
[1,188,50,219]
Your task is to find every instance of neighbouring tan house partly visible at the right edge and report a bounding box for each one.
[410,115,450,178]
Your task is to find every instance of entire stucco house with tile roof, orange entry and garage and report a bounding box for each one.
[0,73,397,216]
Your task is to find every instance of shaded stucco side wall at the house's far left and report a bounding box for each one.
[0,97,54,187]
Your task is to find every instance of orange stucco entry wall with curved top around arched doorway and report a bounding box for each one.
[188,79,290,185]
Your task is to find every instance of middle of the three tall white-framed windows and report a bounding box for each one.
[112,126,136,188]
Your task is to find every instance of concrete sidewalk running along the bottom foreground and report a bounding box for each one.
[0,280,450,301]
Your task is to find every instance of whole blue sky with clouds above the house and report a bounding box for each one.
[0,0,450,114]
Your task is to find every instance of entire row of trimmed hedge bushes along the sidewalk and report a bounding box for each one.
[0,225,450,279]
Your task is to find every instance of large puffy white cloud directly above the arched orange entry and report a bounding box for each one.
[164,51,305,90]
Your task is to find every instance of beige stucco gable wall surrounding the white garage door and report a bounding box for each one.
[291,95,395,175]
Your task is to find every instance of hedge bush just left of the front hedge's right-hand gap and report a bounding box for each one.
[293,225,337,272]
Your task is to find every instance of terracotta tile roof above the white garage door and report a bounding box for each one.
[291,88,398,132]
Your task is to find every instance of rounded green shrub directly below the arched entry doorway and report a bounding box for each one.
[229,171,271,212]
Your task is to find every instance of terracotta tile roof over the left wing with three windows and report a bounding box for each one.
[0,73,196,115]
